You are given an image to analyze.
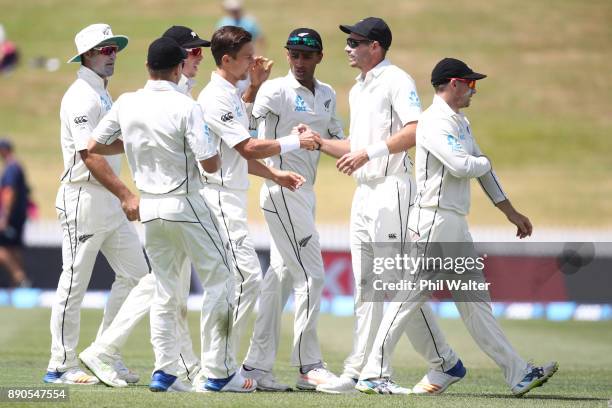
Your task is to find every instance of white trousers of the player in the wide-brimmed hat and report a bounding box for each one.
[48,182,149,372]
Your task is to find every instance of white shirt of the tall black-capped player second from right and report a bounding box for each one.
[349,59,421,182]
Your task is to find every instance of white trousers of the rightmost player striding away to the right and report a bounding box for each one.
[361,208,527,386]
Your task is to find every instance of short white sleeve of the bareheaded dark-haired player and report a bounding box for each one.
[198,94,251,148]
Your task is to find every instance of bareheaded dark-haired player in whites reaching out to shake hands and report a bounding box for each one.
[198,26,316,356]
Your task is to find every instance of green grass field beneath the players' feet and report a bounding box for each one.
[0,308,612,408]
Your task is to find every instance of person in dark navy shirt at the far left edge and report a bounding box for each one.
[0,139,30,287]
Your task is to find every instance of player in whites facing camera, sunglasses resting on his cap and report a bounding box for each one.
[243,28,344,391]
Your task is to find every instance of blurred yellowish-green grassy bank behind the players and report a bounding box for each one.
[0,0,612,228]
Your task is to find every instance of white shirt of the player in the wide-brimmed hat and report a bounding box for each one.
[60,65,121,184]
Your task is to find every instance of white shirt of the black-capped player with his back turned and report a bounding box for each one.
[93,80,217,195]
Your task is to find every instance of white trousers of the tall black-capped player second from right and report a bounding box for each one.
[342,174,459,378]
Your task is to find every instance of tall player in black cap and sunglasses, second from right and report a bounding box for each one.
[317,17,461,394]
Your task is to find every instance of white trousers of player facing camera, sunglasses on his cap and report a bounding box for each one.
[244,183,325,371]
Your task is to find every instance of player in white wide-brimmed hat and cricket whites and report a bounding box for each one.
[44,24,149,384]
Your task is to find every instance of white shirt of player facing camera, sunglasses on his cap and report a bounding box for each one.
[252,71,344,186]
